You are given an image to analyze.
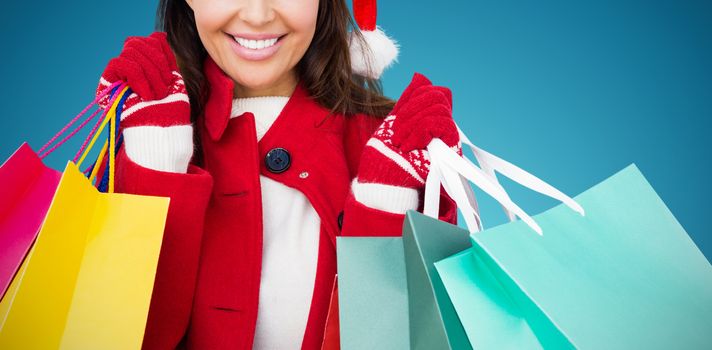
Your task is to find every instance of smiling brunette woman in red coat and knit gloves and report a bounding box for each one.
[99,0,459,349]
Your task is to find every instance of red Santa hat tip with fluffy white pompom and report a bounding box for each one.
[349,0,398,79]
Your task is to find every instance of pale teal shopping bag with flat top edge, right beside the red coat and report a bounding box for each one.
[336,237,410,350]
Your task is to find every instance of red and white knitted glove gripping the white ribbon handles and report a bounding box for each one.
[352,73,462,214]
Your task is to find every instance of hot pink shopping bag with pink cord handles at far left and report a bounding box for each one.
[0,80,124,300]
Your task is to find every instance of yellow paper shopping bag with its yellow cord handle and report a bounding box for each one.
[0,86,168,350]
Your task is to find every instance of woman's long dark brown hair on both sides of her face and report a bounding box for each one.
[156,0,395,121]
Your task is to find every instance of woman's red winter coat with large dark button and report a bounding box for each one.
[116,58,456,350]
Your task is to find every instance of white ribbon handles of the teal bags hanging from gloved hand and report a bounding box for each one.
[423,123,585,235]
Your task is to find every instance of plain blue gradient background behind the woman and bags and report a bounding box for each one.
[0,0,712,259]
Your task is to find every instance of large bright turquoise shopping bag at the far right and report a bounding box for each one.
[435,166,712,349]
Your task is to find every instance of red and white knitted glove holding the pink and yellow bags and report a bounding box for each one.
[97,32,193,173]
